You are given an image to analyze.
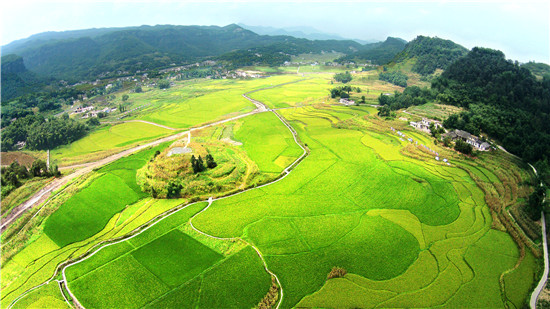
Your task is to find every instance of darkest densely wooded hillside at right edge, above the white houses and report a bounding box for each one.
[432,48,550,162]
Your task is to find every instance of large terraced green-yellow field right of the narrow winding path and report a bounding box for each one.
[191,104,535,307]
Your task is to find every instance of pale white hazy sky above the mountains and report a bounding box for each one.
[0,0,550,63]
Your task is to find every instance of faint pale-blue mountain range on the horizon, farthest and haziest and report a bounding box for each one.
[237,23,378,45]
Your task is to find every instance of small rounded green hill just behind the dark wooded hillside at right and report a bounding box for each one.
[393,35,468,75]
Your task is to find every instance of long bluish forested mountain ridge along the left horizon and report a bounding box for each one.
[4,25,361,81]
